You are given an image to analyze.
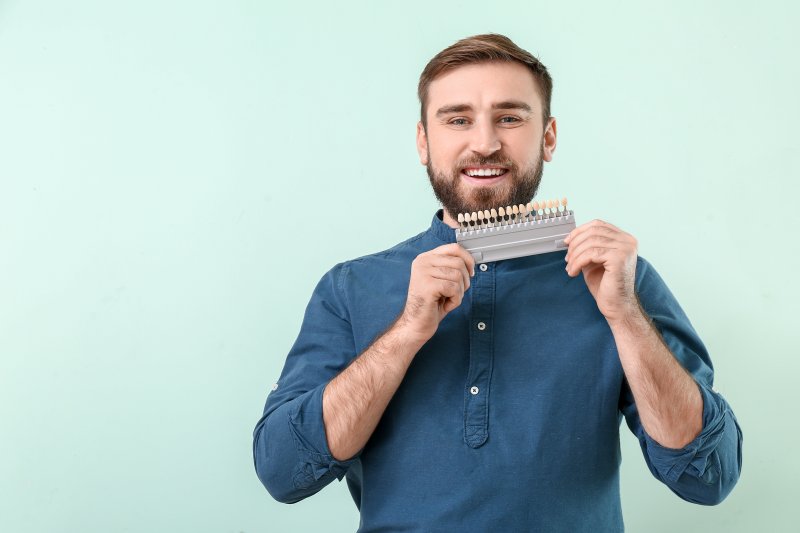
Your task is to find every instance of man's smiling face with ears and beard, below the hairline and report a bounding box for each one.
[417,62,556,225]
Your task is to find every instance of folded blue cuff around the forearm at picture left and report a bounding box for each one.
[288,384,358,489]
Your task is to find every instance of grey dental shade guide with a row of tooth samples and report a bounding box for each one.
[455,198,575,263]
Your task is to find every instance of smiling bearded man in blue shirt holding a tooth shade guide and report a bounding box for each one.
[253,35,742,532]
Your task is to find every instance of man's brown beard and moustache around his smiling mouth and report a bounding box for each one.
[426,147,544,219]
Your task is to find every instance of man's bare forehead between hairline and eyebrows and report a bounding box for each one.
[427,62,541,116]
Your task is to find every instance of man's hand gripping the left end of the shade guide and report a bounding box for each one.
[399,243,475,342]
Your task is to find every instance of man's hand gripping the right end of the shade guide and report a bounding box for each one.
[564,220,639,322]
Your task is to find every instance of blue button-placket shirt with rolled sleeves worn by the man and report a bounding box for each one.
[253,211,742,533]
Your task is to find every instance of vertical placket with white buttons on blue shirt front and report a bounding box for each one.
[464,263,495,448]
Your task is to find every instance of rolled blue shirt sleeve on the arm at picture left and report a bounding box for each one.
[253,263,357,503]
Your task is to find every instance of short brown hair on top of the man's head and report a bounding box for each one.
[417,33,553,129]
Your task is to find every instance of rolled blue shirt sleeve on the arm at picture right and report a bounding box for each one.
[620,258,742,505]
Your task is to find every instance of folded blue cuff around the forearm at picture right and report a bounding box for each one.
[642,384,728,483]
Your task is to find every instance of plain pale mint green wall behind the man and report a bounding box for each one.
[0,0,800,533]
